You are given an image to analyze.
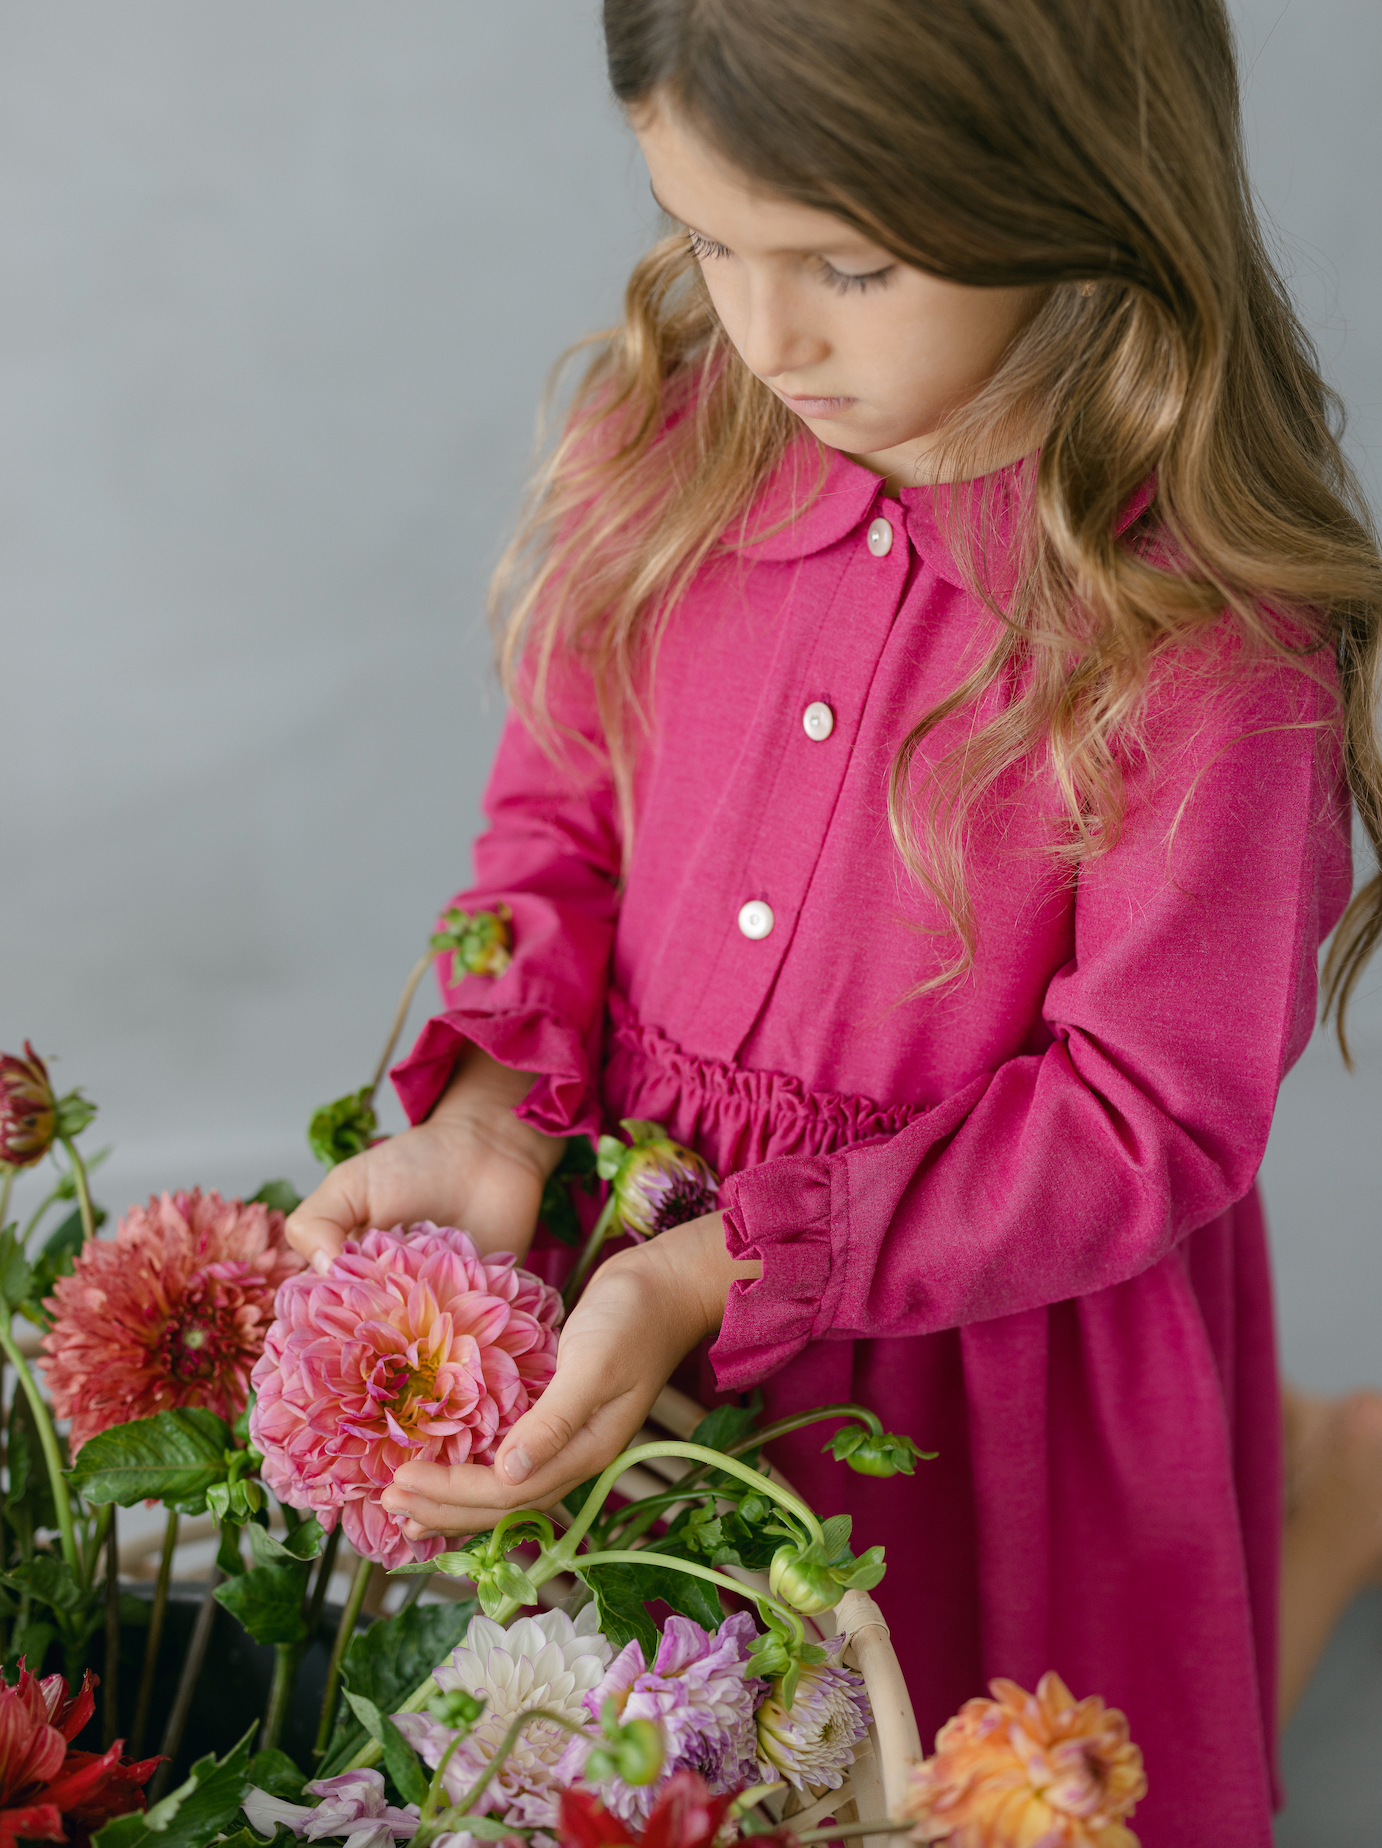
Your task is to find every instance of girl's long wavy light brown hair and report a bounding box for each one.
[493,0,1382,1059]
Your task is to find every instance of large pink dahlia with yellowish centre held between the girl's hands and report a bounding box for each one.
[249,1220,562,1565]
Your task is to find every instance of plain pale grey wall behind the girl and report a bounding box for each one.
[0,0,1382,1839]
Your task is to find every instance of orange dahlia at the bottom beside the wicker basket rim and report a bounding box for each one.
[905,1674,1147,1848]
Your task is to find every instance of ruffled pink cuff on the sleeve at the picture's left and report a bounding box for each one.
[388,1005,600,1138]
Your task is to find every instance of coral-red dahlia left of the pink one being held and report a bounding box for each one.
[41,1188,303,1454]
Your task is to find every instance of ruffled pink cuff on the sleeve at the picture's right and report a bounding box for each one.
[709,1155,833,1392]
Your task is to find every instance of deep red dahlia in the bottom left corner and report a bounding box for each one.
[0,1660,161,1848]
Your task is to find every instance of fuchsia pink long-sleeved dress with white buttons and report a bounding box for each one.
[395,453,1351,1848]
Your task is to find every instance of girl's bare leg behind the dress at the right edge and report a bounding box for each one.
[1277,1386,1382,1726]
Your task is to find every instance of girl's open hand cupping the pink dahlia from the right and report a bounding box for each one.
[381,1212,763,1539]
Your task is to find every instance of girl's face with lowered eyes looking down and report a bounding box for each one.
[634,100,1040,488]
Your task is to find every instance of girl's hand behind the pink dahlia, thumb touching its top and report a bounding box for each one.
[286,1046,564,1271]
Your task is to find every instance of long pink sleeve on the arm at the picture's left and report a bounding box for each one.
[392,673,621,1137]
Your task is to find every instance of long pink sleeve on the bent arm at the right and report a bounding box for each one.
[713,646,1351,1390]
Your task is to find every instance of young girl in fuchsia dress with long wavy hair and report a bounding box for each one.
[294,0,1382,1848]
